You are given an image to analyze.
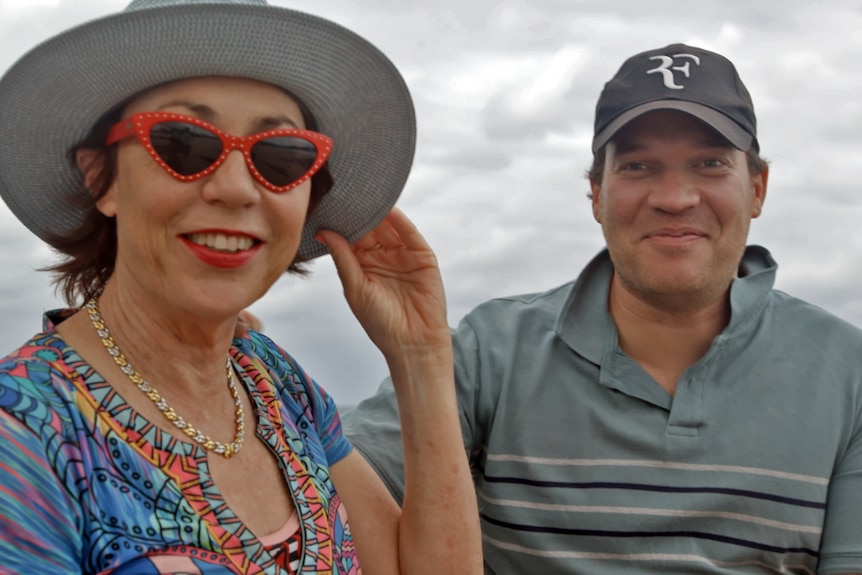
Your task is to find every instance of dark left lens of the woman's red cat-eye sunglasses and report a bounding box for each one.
[150,122,222,176]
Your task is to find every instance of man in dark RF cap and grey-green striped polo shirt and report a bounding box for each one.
[346,45,862,575]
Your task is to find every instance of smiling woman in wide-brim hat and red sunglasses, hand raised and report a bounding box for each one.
[0,0,481,574]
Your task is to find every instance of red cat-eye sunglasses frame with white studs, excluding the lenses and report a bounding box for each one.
[105,112,332,193]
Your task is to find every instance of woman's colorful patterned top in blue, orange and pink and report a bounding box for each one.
[0,312,360,575]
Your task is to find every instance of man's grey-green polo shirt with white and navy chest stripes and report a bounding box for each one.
[345,247,862,575]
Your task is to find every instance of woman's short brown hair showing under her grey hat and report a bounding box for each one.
[43,98,335,307]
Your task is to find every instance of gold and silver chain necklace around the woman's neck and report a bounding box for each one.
[87,298,245,458]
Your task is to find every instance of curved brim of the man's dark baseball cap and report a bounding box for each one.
[593,100,754,153]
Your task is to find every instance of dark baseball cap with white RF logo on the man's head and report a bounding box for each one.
[593,44,760,153]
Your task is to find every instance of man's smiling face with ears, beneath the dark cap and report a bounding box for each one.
[591,110,767,308]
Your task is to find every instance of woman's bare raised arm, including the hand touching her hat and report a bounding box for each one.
[319,209,482,574]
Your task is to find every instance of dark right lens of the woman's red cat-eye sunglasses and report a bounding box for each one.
[251,136,317,187]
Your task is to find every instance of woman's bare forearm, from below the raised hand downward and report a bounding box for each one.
[387,346,482,575]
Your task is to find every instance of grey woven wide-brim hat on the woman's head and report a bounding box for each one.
[0,0,416,259]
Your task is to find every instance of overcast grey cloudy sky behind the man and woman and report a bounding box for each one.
[0,0,862,405]
